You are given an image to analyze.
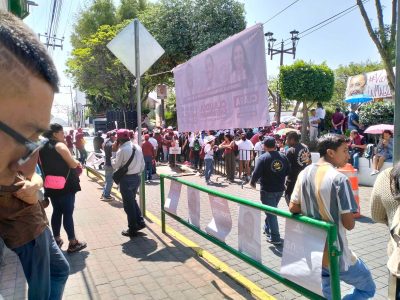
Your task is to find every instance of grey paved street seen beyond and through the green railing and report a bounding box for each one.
[139,166,388,299]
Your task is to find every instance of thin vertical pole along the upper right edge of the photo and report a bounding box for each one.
[393,1,400,166]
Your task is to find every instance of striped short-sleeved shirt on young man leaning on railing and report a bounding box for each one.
[290,162,357,271]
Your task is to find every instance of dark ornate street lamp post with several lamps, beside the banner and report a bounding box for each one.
[264,30,300,125]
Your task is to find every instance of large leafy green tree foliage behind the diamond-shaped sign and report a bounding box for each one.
[67,0,246,116]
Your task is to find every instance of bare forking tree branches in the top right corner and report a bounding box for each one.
[356,0,397,95]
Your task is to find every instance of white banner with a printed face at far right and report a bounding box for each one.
[346,70,392,98]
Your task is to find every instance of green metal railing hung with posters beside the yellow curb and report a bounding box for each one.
[160,174,341,300]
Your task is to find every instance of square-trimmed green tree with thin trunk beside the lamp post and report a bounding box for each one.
[279,60,335,143]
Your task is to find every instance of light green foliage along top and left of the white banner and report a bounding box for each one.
[327,60,384,110]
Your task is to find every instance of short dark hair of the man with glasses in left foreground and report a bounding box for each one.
[0,10,59,92]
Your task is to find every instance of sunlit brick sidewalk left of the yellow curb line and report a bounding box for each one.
[0,175,252,300]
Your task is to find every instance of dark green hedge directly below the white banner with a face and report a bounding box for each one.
[360,101,394,127]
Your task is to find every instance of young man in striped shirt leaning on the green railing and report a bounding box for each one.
[289,133,375,299]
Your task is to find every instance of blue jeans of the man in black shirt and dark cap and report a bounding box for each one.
[260,191,283,242]
